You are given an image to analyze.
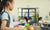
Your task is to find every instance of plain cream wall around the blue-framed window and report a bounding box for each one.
[12,0,50,20]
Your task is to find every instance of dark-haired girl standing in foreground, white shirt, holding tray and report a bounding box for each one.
[0,0,23,30]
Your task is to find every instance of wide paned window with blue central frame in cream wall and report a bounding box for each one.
[19,8,38,20]
